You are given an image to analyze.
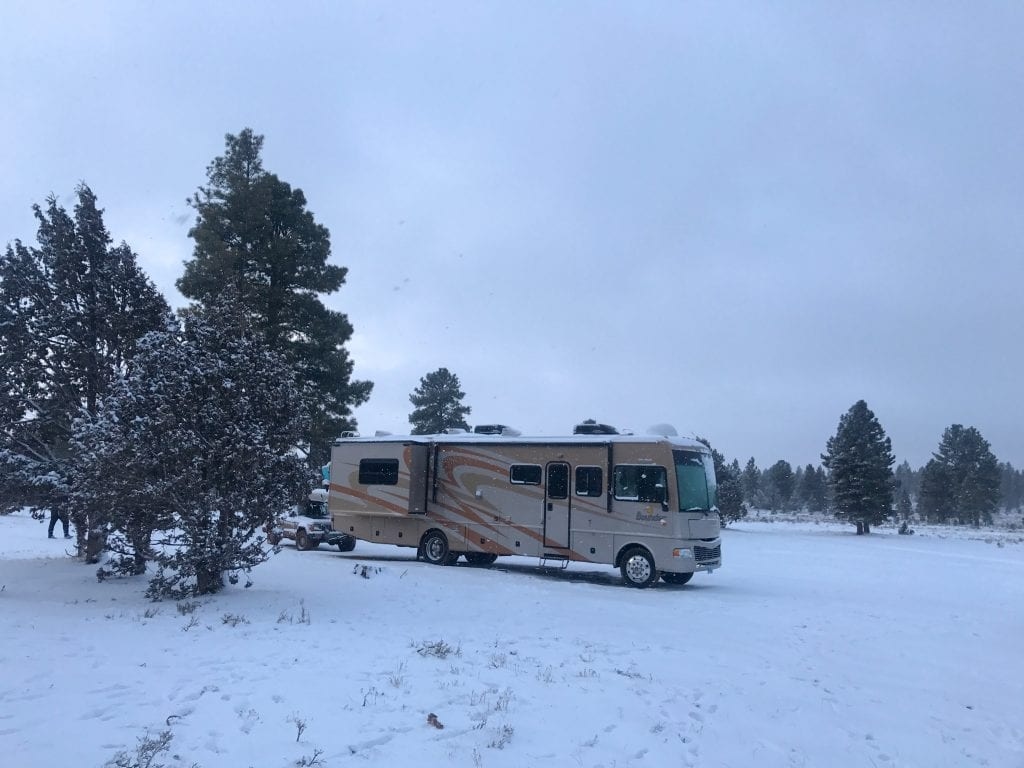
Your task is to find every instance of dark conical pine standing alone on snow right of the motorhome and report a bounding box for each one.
[821,400,896,534]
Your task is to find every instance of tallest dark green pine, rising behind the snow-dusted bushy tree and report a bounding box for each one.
[177,128,373,467]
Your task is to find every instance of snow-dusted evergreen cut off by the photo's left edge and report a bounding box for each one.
[0,183,170,536]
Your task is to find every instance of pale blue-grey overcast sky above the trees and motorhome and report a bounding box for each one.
[0,0,1024,467]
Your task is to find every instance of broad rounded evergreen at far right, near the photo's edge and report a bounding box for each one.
[921,424,1000,526]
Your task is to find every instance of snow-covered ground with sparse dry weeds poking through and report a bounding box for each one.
[0,515,1024,768]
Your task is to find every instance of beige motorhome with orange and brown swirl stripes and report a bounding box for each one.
[328,434,722,587]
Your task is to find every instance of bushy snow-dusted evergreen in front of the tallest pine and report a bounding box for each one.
[70,290,311,598]
